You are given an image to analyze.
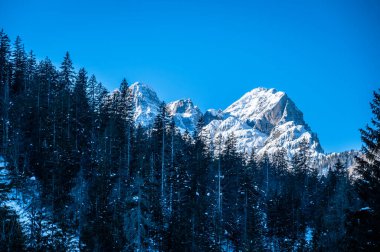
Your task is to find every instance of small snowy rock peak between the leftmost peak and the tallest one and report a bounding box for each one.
[166,99,202,132]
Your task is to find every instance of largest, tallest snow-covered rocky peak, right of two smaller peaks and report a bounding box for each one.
[205,87,323,156]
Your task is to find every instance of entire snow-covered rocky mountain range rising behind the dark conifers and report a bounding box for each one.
[130,82,358,170]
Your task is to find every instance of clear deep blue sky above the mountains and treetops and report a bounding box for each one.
[0,0,380,152]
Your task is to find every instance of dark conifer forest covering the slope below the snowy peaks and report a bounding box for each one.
[0,31,380,251]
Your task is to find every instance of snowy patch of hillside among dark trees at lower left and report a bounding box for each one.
[0,156,80,251]
